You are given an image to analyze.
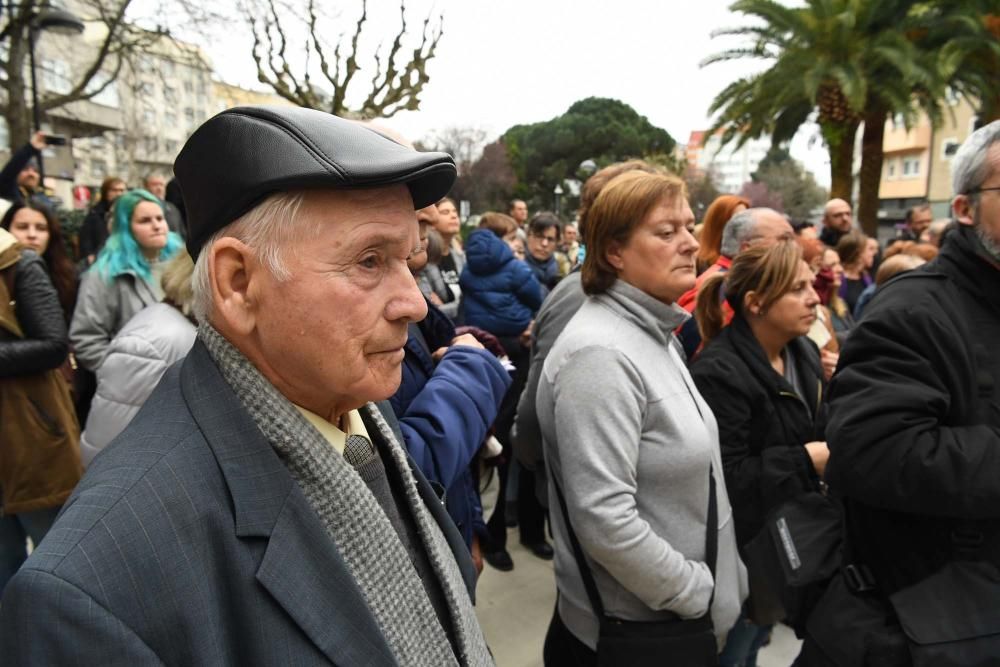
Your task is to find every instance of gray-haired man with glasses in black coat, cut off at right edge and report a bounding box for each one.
[806,121,1000,666]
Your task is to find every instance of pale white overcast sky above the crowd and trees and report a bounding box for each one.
[152,0,829,185]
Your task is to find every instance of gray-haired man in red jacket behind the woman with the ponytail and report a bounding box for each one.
[677,208,795,360]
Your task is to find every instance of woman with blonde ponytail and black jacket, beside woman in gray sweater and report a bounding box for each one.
[691,242,829,667]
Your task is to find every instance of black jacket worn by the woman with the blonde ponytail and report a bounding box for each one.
[691,315,824,553]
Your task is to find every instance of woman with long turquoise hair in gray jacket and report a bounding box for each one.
[69,190,183,371]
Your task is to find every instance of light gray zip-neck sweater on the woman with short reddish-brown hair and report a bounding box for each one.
[536,281,747,648]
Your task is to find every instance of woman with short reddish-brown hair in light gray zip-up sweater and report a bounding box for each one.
[536,171,746,667]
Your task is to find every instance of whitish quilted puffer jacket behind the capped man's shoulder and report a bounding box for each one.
[80,303,197,466]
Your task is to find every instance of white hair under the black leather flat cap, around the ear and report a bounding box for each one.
[191,192,306,322]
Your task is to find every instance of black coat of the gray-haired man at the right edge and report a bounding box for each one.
[827,226,1000,594]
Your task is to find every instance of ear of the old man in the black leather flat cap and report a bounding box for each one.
[206,236,263,335]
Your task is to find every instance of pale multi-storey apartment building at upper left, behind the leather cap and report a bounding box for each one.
[0,2,287,208]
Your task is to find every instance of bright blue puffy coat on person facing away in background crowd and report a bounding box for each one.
[459,229,542,336]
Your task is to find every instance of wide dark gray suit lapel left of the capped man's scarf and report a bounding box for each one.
[181,340,396,666]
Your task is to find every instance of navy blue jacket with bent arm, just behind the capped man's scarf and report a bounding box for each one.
[389,303,511,546]
